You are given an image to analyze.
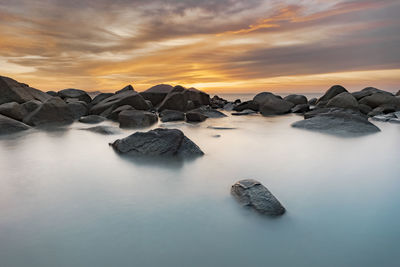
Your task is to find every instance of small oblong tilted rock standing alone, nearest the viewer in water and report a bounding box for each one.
[231,179,286,216]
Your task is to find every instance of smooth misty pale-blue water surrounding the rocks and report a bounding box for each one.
[0,94,400,267]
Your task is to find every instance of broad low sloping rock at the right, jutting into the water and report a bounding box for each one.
[292,108,380,137]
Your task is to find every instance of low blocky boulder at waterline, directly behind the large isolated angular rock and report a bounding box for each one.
[118,110,158,128]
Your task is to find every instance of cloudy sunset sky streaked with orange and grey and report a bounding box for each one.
[0,0,400,93]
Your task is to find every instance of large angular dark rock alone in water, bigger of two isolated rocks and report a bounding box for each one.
[112,128,204,157]
